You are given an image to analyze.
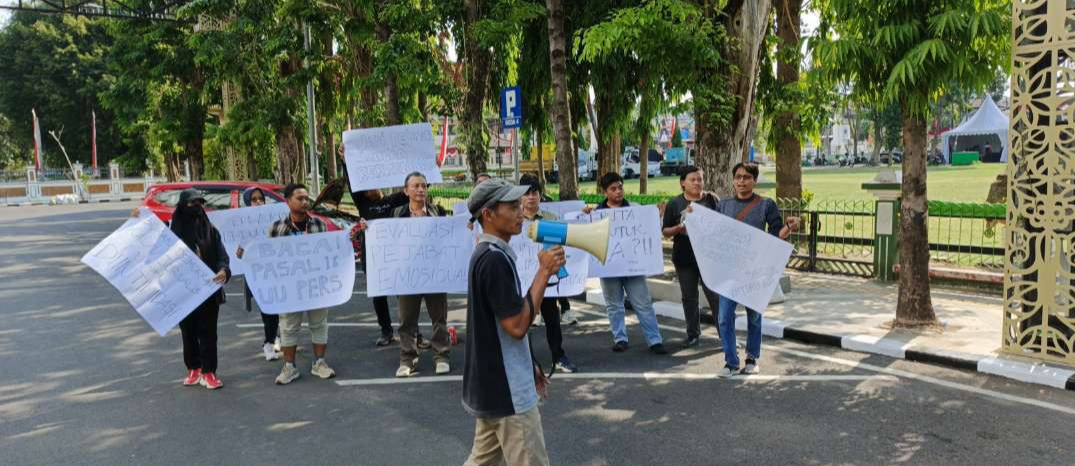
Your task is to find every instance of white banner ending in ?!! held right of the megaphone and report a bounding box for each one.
[582,206,664,278]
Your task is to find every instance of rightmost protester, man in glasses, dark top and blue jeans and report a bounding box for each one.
[717,163,799,377]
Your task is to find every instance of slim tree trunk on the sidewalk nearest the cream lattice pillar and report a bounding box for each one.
[895,108,936,327]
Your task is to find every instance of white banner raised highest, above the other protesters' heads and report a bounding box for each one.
[343,123,444,193]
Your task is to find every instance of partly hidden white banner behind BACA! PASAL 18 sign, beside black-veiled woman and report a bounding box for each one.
[206,202,288,276]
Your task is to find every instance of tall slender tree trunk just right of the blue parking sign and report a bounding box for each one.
[545,0,578,200]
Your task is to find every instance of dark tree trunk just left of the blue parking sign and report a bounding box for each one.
[461,0,492,180]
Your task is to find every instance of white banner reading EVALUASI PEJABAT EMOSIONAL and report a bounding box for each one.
[366,215,474,297]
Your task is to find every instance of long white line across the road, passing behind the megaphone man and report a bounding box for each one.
[335,372,900,386]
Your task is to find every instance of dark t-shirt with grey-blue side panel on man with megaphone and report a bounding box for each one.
[463,235,538,418]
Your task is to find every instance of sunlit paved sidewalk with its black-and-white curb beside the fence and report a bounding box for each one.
[587,266,1075,390]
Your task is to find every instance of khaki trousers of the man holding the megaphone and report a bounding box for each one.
[463,407,548,466]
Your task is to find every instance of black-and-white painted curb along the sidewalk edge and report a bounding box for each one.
[586,290,1075,391]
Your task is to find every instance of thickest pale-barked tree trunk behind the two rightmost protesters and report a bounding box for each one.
[696,0,772,197]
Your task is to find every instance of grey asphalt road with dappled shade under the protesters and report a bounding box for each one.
[0,204,1075,466]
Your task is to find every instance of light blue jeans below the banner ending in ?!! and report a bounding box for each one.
[601,276,662,347]
